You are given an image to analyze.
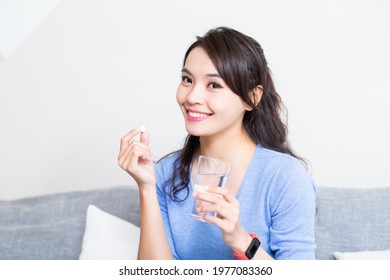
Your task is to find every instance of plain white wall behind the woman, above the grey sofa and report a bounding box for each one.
[0,0,390,199]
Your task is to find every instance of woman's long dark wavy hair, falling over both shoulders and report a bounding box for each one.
[160,27,306,201]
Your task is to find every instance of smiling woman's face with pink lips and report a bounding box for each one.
[176,47,247,139]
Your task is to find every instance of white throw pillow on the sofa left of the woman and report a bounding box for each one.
[79,205,140,260]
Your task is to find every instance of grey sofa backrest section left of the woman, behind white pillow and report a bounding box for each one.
[0,187,139,259]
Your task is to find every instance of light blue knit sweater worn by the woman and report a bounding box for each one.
[155,145,316,260]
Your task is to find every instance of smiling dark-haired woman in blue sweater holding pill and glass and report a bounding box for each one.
[118,27,316,259]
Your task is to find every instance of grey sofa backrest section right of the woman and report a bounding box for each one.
[315,187,390,259]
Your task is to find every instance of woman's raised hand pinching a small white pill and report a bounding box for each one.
[118,129,156,187]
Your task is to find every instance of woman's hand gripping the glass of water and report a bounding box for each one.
[193,187,249,251]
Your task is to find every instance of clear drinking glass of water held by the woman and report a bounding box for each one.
[191,156,232,222]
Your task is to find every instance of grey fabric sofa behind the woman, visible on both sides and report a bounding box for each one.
[0,186,390,259]
